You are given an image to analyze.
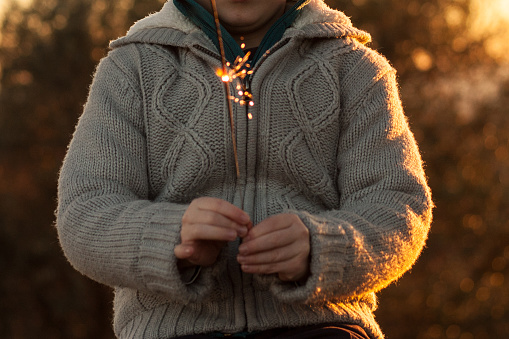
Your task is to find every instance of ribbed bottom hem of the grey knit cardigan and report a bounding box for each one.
[112,291,384,339]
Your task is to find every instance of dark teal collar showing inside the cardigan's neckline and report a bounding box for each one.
[173,0,310,65]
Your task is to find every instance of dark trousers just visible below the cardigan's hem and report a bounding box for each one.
[178,324,369,339]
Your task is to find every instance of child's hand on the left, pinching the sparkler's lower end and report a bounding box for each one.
[174,198,251,267]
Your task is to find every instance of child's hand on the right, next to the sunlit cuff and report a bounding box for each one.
[237,214,310,281]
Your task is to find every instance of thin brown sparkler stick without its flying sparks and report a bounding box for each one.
[210,0,244,209]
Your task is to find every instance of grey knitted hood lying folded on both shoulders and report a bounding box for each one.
[110,0,371,48]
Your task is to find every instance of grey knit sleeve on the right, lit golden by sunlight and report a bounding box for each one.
[272,53,433,303]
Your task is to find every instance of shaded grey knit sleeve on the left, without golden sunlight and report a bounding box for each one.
[56,51,211,302]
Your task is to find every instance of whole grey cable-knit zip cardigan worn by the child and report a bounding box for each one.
[56,0,432,339]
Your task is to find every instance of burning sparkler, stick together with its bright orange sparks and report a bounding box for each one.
[210,0,254,209]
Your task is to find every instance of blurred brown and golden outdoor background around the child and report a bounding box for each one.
[0,0,509,339]
